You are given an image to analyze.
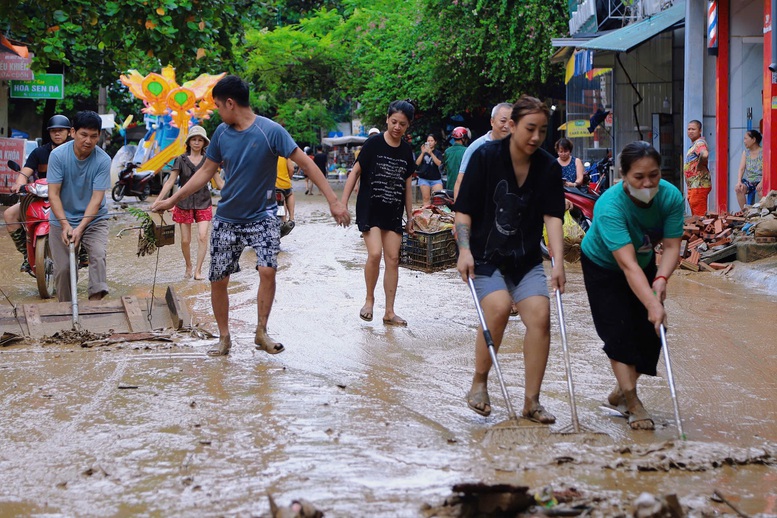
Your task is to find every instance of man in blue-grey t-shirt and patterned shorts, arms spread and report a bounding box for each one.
[151,75,351,356]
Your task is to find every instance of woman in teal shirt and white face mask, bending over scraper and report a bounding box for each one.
[581,142,684,430]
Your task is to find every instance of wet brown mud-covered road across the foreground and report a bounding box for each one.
[0,188,777,516]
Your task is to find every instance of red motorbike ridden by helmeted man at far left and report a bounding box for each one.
[8,160,54,299]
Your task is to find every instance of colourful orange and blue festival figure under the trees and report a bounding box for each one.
[120,65,226,172]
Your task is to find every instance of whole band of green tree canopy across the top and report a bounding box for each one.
[0,0,568,142]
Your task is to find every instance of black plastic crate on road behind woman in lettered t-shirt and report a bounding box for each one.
[399,230,459,272]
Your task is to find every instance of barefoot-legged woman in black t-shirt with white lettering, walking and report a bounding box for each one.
[341,101,415,326]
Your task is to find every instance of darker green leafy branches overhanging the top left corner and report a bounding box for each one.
[0,0,242,93]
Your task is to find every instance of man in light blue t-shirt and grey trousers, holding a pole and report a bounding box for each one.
[46,111,111,302]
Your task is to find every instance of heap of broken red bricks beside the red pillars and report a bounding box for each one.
[660,213,745,272]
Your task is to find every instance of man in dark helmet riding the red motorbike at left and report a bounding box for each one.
[3,115,70,275]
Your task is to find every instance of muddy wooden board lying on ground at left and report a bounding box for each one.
[0,286,190,338]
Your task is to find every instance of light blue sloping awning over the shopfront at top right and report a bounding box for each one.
[577,2,685,52]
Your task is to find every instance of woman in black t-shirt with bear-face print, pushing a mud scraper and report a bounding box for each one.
[454,96,566,424]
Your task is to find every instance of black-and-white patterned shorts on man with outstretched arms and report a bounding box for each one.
[208,218,281,282]
